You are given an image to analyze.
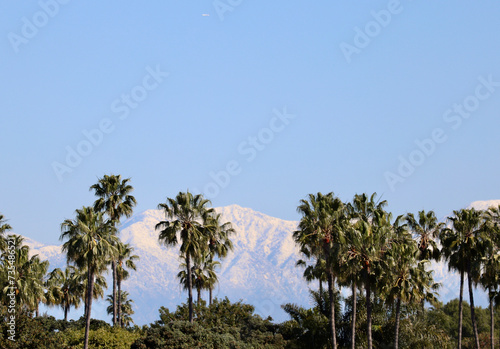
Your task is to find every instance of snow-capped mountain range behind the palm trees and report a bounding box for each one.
[26,200,500,325]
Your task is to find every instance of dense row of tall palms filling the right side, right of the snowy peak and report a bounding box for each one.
[292,193,500,349]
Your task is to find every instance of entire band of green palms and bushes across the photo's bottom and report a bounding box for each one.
[0,181,500,349]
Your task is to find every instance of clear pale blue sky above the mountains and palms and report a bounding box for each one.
[0,0,500,243]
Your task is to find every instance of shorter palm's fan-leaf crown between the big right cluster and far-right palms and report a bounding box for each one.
[406,210,444,261]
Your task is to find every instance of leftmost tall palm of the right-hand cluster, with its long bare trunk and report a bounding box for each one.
[293,193,346,348]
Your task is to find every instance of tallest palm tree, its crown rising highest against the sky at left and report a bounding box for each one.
[90,175,137,326]
